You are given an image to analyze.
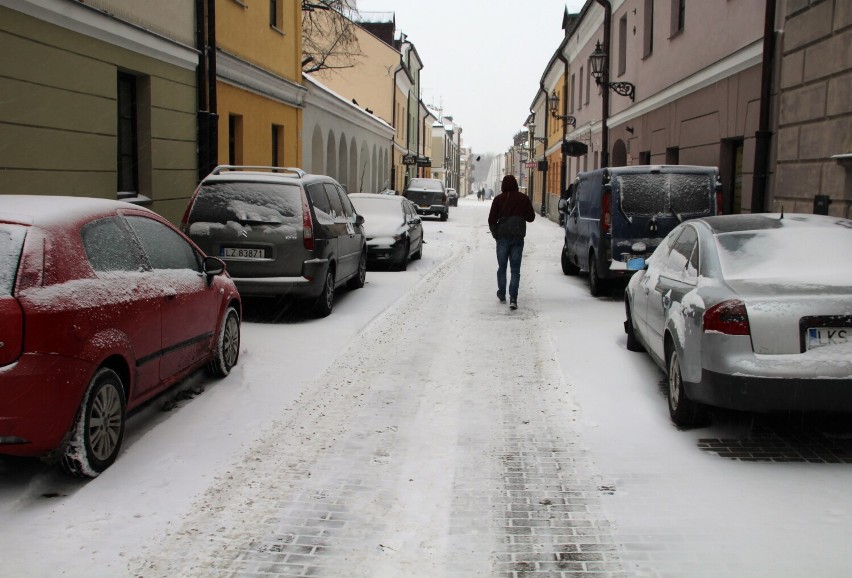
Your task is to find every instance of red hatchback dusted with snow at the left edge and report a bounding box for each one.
[0,195,242,477]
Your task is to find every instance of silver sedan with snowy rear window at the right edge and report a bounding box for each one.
[624,214,852,427]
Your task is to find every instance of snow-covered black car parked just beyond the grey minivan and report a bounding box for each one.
[349,193,423,271]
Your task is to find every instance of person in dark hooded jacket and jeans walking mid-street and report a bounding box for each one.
[488,175,535,310]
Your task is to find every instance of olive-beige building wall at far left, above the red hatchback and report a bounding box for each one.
[0,0,197,222]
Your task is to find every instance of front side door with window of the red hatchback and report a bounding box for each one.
[127,215,221,380]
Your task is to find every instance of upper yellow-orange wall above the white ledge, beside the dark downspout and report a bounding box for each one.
[216,0,302,84]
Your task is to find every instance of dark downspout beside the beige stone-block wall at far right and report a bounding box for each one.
[751,0,777,213]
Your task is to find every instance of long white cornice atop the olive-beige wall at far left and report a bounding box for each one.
[0,0,199,70]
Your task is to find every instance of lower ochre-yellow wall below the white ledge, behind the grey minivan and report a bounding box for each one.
[217,82,302,167]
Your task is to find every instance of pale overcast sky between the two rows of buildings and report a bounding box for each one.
[357,0,584,153]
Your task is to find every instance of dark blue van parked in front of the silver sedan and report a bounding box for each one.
[559,165,722,296]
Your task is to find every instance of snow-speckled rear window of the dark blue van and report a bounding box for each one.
[616,173,715,216]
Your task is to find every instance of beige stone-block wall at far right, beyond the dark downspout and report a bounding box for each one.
[771,0,852,218]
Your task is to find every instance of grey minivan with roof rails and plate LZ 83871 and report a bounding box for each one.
[182,165,367,317]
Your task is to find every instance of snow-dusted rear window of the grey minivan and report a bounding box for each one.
[189,182,302,227]
